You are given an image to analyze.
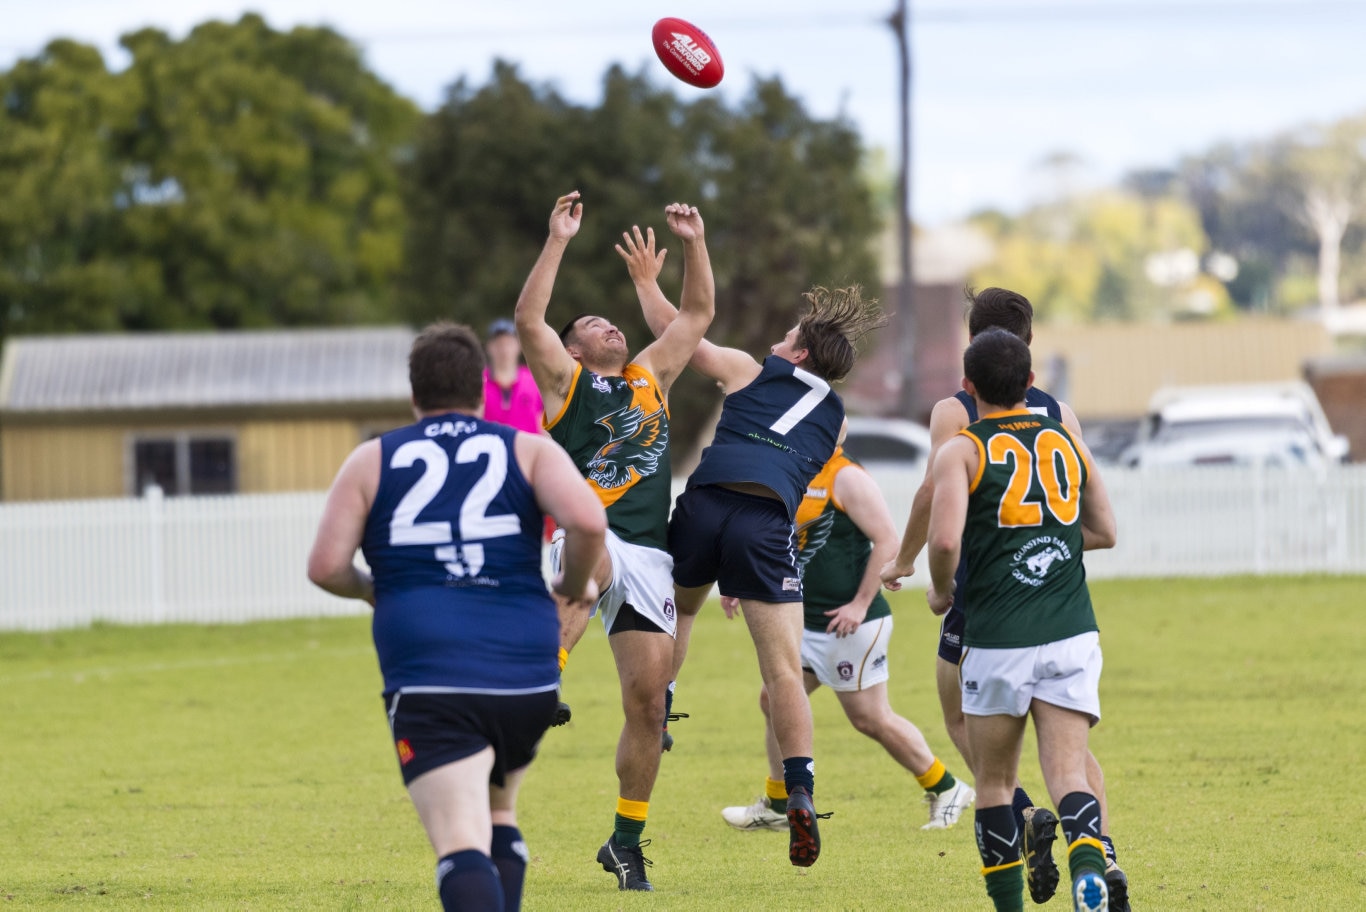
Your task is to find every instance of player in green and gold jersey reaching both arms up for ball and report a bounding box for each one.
[515,191,716,890]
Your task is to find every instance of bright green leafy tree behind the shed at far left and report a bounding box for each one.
[0,15,421,338]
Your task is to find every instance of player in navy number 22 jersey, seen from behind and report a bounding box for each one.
[309,324,607,912]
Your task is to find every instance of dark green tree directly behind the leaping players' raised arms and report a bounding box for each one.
[404,63,878,446]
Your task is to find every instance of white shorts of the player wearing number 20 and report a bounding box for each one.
[958,631,1104,725]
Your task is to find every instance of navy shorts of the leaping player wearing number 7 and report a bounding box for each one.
[669,485,802,602]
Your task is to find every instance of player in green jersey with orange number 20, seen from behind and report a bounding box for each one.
[928,329,1115,912]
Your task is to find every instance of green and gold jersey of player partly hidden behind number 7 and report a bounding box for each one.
[796,448,892,631]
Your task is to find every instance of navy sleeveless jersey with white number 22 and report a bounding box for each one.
[361,412,560,694]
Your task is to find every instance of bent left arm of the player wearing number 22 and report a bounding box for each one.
[309,440,380,605]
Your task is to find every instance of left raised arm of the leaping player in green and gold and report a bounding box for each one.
[514,190,583,415]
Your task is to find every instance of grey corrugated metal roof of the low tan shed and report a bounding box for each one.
[0,326,414,414]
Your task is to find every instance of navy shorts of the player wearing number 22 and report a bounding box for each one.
[384,691,559,788]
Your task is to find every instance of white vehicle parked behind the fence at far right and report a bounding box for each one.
[1120,382,1348,468]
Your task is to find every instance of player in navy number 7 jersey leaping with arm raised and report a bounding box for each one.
[626,264,885,867]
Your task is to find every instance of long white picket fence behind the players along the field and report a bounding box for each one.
[0,466,1366,629]
